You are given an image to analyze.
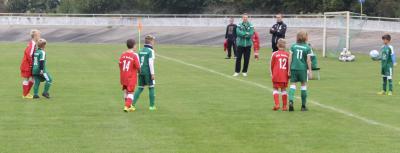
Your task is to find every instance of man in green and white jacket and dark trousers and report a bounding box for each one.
[233,14,254,76]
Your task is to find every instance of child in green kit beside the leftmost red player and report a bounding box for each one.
[32,39,53,99]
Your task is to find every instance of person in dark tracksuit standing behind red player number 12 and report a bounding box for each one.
[269,14,287,52]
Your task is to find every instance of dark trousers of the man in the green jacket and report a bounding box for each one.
[235,46,251,73]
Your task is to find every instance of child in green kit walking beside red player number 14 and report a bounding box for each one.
[133,35,156,111]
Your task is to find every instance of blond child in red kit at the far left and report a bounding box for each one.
[20,29,40,99]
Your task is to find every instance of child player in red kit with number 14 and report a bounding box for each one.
[119,39,140,112]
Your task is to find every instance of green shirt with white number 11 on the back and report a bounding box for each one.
[290,43,313,70]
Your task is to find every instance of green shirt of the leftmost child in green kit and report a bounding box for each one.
[32,48,47,75]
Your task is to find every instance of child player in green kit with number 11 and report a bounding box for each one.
[289,31,313,111]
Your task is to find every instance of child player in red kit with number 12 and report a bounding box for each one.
[271,39,289,111]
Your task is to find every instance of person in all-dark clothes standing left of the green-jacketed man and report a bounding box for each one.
[225,18,237,59]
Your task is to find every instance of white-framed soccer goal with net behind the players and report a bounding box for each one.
[322,11,367,57]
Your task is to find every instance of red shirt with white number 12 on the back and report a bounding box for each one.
[271,50,289,83]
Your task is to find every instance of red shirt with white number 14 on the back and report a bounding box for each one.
[119,51,140,86]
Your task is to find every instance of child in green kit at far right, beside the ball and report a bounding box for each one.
[378,34,394,96]
